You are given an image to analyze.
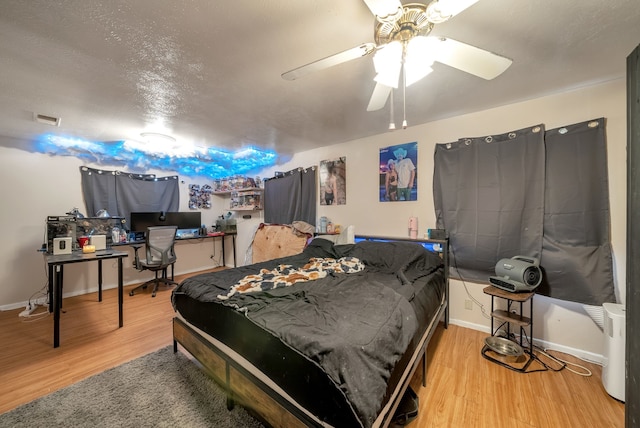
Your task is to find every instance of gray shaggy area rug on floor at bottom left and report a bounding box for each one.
[0,346,262,428]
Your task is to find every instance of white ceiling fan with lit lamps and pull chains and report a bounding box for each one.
[282,0,512,111]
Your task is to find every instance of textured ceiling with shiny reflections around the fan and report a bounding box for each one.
[0,0,640,159]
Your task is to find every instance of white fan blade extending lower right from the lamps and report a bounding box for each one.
[434,37,513,80]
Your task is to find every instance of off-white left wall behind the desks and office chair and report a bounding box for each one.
[0,147,244,310]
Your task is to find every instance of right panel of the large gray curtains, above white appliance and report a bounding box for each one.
[536,118,616,306]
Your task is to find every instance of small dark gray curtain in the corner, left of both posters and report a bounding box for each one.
[264,168,317,225]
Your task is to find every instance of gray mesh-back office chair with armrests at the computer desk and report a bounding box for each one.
[129,226,178,297]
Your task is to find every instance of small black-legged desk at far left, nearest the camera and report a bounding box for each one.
[45,250,129,348]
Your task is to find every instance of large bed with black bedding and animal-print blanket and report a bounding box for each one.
[172,236,449,428]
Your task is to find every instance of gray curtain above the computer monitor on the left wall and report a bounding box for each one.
[80,166,180,224]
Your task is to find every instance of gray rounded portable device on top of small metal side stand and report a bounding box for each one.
[489,256,542,292]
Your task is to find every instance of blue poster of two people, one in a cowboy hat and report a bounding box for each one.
[379,142,418,202]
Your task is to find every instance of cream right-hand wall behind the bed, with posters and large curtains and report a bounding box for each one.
[261,79,626,360]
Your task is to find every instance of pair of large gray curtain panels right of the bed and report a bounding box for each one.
[433,118,615,305]
